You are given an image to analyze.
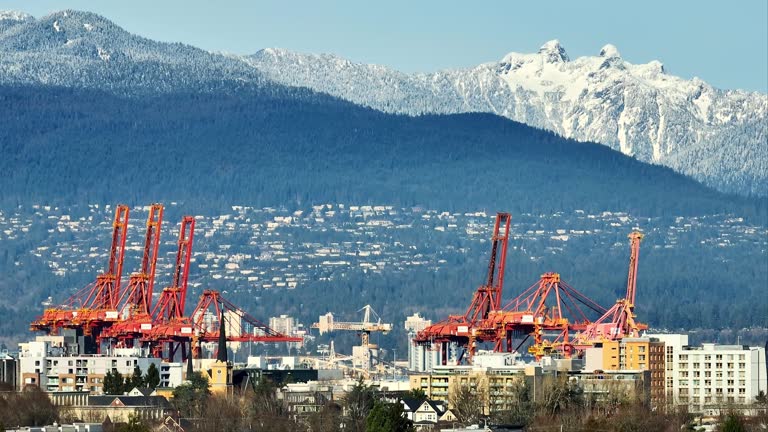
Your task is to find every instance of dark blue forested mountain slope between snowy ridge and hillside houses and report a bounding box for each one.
[0,84,766,220]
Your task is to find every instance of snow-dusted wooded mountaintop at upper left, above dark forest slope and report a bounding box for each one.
[0,10,265,95]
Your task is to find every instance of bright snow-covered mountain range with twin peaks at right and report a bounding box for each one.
[248,40,768,196]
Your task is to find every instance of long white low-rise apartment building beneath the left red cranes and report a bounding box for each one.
[18,336,181,394]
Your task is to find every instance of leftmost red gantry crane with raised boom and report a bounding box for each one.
[30,205,129,351]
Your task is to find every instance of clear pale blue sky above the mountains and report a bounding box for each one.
[0,0,768,93]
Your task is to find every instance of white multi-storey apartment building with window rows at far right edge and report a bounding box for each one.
[646,334,768,415]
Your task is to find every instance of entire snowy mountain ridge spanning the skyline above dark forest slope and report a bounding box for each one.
[0,10,768,201]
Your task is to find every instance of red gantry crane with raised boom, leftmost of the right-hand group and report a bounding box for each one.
[413,213,512,365]
